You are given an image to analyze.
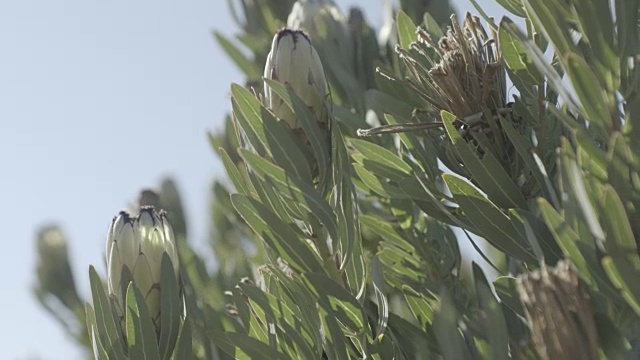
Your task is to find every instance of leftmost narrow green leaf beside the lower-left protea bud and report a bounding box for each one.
[89,266,127,359]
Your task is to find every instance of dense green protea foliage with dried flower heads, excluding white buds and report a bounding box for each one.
[37,0,640,359]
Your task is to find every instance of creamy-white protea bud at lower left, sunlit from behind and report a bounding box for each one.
[106,206,179,325]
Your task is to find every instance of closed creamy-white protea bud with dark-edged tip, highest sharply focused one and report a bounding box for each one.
[264,29,327,129]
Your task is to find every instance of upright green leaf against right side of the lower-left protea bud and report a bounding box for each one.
[158,252,182,360]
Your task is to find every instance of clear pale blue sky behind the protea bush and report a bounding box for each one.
[0,0,501,359]
